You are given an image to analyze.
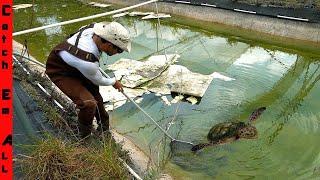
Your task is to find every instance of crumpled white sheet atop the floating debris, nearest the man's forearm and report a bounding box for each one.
[107,54,180,88]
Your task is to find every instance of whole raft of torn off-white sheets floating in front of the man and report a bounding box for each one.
[100,54,234,110]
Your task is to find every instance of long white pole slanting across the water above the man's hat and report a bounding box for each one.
[12,0,158,36]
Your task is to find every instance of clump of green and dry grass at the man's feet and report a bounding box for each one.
[18,136,129,179]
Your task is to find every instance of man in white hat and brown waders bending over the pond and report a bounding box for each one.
[46,22,131,138]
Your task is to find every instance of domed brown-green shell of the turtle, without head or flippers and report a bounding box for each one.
[207,122,247,142]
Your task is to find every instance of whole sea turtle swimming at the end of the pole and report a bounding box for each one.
[191,107,266,152]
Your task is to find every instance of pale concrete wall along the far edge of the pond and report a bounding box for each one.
[102,0,320,43]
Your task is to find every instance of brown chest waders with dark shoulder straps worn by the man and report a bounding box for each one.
[46,24,109,138]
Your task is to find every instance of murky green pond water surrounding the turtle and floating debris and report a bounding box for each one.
[14,0,320,179]
